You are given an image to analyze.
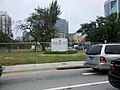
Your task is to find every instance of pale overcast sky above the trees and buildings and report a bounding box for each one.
[0,0,106,33]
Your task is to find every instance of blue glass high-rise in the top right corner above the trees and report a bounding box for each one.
[104,0,120,16]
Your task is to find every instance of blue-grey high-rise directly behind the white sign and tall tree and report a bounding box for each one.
[55,18,68,37]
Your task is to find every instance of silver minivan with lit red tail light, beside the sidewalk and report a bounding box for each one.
[84,44,120,70]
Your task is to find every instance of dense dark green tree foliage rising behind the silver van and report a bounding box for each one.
[77,13,120,42]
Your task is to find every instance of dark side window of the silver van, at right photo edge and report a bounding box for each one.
[105,45,120,54]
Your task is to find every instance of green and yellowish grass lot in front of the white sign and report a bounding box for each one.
[0,50,85,65]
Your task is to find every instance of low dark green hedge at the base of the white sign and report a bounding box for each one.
[44,50,77,54]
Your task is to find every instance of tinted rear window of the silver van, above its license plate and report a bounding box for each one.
[86,45,102,55]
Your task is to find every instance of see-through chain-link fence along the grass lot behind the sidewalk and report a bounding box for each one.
[0,42,106,65]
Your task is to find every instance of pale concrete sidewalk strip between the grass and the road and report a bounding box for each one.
[3,61,85,73]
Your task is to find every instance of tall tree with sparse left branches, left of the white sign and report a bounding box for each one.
[21,1,61,51]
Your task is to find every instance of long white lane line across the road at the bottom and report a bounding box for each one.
[44,81,109,90]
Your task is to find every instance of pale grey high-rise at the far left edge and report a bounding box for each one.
[0,11,12,36]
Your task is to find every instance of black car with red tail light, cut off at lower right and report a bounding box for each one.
[108,58,120,89]
